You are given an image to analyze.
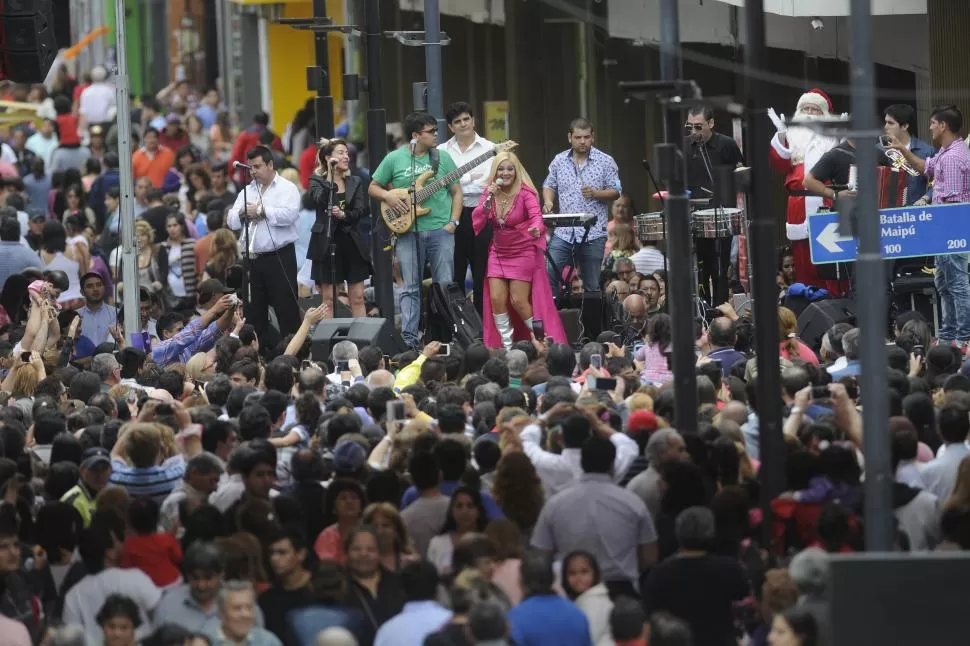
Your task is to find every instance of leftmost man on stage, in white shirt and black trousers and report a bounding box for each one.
[227,145,302,338]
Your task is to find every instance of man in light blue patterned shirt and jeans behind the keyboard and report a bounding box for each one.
[542,118,623,295]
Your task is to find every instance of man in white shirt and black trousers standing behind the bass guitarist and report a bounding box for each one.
[438,101,495,315]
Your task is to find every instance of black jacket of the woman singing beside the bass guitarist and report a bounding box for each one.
[303,175,370,264]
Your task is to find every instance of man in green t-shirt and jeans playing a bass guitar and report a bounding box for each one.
[368,112,462,349]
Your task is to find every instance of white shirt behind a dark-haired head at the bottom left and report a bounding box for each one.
[64,567,162,644]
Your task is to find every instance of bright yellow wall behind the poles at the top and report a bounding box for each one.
[265,0,344,133]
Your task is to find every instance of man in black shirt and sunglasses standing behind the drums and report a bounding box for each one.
[684,106,744,305]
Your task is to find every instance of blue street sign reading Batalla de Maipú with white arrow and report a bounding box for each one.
[808,204,970,265]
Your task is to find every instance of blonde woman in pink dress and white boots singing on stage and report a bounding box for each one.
[472,152,566,349]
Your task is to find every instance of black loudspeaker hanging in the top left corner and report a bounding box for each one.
[0,0,57,83]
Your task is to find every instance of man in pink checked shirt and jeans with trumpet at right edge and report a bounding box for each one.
[890,105,970,350]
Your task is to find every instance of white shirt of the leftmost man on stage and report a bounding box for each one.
[227,173,300,253]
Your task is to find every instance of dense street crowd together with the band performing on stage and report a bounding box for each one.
[0,54,970,646]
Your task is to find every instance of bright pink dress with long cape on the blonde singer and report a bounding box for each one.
[472,185,566,348]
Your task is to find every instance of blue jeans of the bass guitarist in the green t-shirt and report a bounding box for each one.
[396,228,455,348]
